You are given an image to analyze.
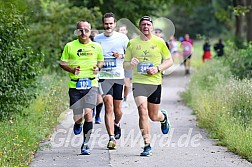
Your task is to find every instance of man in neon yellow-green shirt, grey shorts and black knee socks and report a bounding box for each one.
[60,20,104,155]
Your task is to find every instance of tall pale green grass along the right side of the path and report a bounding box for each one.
[182,60,252,161]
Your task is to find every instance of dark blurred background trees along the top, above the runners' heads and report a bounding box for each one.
[71,0,231,37]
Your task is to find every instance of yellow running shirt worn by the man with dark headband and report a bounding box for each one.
[124,35,171,85]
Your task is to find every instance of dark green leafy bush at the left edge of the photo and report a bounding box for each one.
[0,0,42,119]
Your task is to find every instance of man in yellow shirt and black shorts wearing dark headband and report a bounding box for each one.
[124,16,173,156]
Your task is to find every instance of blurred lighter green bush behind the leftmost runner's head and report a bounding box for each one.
[27,0,101,70]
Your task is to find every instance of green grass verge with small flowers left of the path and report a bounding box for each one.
[0,74,68,166]
